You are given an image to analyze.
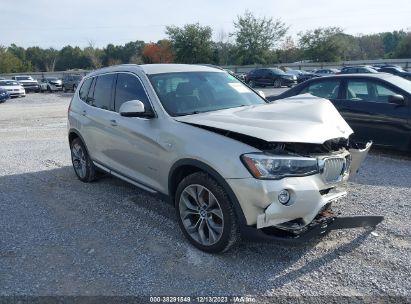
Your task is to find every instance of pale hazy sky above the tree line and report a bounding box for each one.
[0,0,411,49]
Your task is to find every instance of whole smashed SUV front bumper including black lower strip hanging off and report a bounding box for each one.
[227,143,382,239]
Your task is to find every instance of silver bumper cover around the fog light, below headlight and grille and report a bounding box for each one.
[227,174,346,228]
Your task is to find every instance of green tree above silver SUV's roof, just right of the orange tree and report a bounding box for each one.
[166,23,213,63]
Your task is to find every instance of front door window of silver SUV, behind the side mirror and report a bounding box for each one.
[114,73,151,112]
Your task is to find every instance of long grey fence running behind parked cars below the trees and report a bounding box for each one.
[0,58,411,79]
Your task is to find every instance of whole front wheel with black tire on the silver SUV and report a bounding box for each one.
[174,172,240,253]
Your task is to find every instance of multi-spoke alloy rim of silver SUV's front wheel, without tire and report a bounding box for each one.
[179,185,224,246]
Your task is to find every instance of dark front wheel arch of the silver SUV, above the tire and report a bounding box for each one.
[168,158,247,228]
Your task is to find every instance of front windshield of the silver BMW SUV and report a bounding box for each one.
[149,72,265,116]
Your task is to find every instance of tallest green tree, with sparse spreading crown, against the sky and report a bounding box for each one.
[232,11,288,64]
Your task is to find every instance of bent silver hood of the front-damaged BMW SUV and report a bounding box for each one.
[174,94,353,144]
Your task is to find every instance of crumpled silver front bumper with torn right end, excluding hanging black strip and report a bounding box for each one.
[226,143,372,231]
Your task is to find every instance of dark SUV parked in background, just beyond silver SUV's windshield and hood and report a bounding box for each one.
[245,68,297,88]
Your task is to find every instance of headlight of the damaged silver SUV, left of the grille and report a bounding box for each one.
[241,153,319,179]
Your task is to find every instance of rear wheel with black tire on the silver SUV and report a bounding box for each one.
[70,138,96,183]
